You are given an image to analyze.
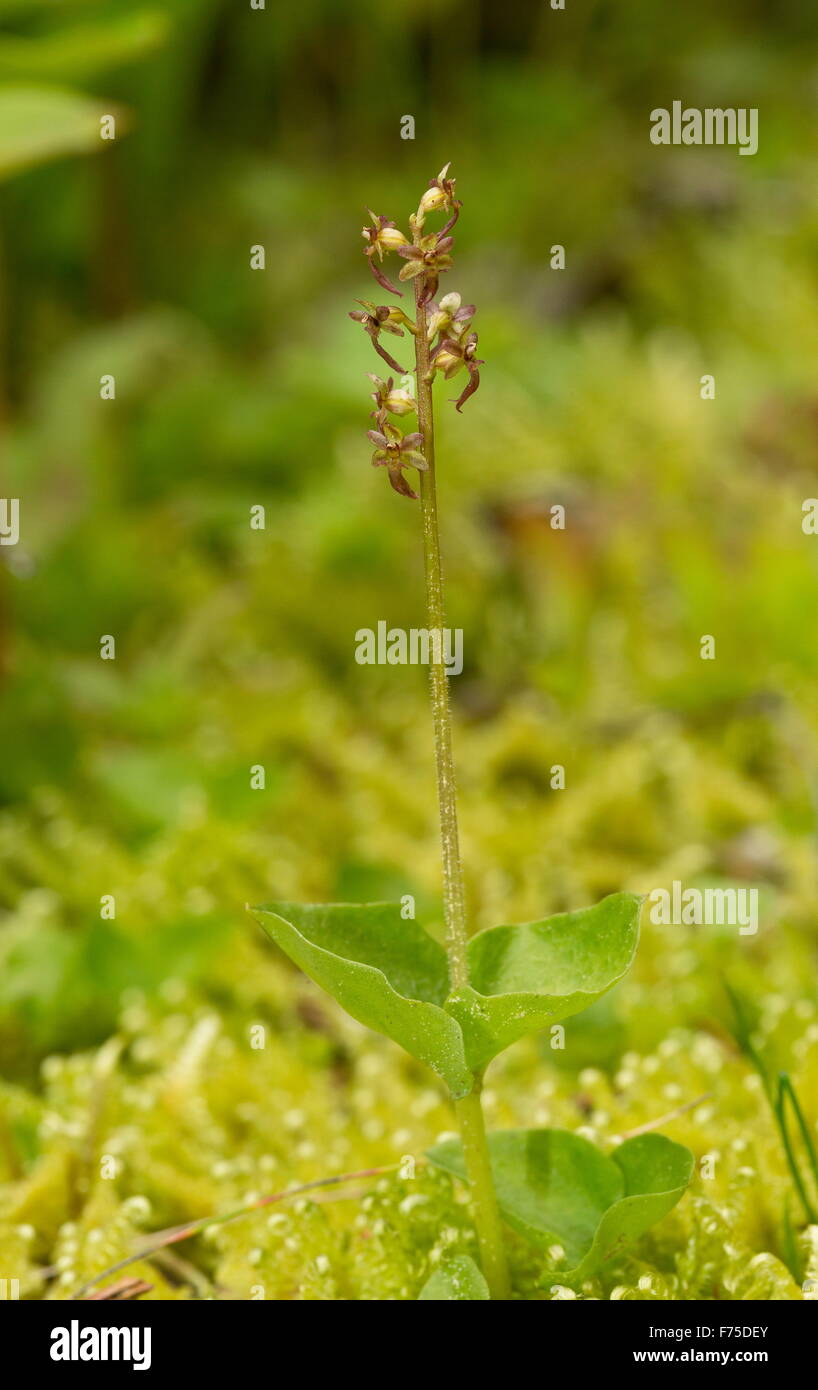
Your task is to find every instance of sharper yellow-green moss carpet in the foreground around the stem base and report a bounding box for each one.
[0,984,818,1301]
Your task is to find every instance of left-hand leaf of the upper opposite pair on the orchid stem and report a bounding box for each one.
[252,902,474,1097]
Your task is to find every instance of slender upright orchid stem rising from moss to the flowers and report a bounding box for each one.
[415,273,511,1300]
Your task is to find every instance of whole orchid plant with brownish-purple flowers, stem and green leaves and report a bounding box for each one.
[253,165,693,1300]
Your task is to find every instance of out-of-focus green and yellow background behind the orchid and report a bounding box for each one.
[0,0,818,1301]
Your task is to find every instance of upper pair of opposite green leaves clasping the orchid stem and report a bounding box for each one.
[253,892,641,1099]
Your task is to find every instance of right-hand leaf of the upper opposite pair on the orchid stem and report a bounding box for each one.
[447,892,641,1070]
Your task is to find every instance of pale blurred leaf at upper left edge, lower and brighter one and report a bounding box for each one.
[0,86,118,177]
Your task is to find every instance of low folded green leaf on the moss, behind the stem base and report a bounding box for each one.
[428,1129,693,1279]
